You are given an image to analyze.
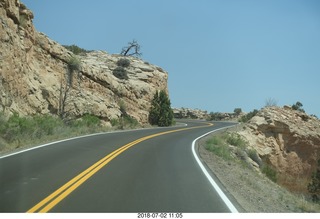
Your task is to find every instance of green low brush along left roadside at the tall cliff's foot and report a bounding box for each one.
[0,113,105,150]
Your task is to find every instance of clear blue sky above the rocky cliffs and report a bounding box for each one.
[22,0,320,117]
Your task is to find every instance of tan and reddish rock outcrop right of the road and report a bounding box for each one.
[239,106,320,192]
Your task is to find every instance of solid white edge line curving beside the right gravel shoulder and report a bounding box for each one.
[192,126,239,213]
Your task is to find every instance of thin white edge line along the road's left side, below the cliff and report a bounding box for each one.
[0,123,188,159]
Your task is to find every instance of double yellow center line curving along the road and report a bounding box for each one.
[27,123,213,213]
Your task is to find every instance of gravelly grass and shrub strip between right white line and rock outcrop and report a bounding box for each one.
[199,131,320,213]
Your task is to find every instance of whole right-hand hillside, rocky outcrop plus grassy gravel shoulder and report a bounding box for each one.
[199,106,320,213]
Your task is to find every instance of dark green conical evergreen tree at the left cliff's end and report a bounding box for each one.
[149,90,173,126]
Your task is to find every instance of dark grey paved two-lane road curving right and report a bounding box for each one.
[0,121,239,212]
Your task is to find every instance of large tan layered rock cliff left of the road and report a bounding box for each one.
[0,0,168,123]
